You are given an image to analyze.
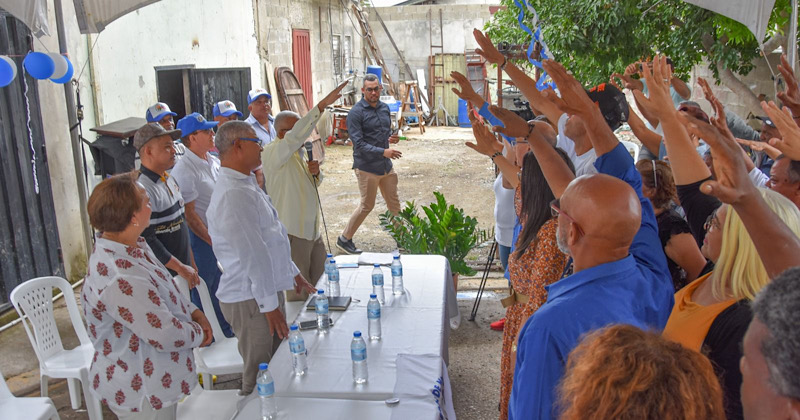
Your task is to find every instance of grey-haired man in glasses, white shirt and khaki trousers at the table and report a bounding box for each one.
[206,121,315,395]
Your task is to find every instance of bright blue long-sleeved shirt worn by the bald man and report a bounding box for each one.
[508,144,674,420]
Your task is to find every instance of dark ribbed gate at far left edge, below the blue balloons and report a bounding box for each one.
[0,9,64,312]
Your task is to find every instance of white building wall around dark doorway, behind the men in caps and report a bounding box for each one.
[87,0,263,124]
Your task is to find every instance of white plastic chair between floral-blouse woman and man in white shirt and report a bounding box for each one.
[175,276,244,390]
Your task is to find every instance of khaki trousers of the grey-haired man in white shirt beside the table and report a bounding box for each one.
[219,292,286,395]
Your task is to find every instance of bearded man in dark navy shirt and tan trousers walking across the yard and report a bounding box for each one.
[336,74,403,254]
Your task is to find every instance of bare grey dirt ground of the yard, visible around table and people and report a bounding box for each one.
[0,127,505,420]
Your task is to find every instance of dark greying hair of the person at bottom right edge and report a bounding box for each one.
[753,267,800,400]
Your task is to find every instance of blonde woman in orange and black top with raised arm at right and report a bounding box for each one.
[637,56,800,420]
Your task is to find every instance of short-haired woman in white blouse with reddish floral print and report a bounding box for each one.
[81,173,213,419]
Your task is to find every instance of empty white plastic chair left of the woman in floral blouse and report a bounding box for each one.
[10,277,103,420]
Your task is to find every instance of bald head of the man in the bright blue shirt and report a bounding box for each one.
[559,174,642,267]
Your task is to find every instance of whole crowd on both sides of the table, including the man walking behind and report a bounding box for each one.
[70,23,800,420]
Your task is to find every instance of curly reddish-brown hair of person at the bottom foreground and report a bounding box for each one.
[559,325,725,420]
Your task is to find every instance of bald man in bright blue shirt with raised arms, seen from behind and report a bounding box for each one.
[493,61,674,420]
